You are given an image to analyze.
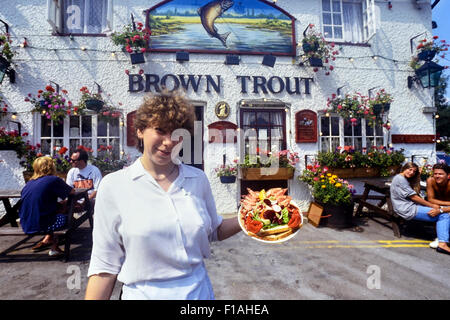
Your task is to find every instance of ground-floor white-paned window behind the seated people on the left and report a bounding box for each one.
[38,115,123,159]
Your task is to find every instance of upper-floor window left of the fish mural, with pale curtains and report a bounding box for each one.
[47,0,113,35]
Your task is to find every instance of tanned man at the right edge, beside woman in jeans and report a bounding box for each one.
[427,163,450,249]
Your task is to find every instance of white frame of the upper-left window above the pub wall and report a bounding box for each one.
[47,0,114,37]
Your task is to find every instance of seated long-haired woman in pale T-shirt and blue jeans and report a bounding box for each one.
[390,162,450,254]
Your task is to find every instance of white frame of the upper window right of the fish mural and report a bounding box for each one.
[320,0,377,44]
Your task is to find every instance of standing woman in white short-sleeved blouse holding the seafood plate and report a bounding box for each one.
[85,92,241,300]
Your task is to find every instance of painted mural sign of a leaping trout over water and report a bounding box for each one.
[146,0,296,56]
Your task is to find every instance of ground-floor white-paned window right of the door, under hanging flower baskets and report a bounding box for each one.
[320,115,387,152]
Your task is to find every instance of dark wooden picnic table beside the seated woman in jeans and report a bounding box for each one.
[355,179,401,238]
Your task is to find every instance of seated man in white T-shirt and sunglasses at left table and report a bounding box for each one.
[66,149,102,204]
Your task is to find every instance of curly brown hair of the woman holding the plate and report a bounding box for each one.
[134,89,195,152]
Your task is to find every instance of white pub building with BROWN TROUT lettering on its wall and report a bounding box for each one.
[0,0,438,213]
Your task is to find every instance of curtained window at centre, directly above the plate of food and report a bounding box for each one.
[241,109,286,154]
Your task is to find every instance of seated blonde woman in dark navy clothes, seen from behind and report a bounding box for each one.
[19,156,75,256]
